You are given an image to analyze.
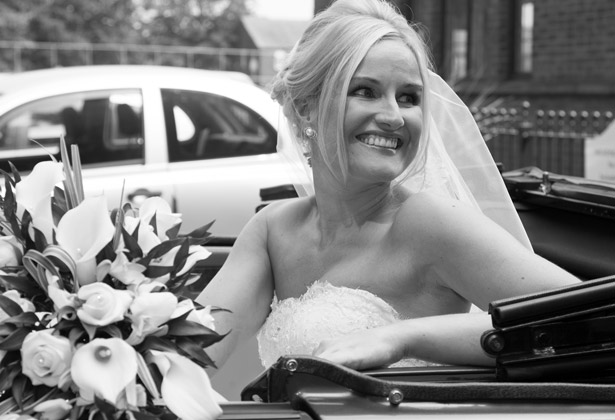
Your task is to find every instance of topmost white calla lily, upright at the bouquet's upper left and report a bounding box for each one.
[15,161,64,243]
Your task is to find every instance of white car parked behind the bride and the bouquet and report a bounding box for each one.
[0,65,291,240]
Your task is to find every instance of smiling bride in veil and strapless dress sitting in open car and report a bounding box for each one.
[198,0,578,368]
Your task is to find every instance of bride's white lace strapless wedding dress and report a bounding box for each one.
[257,281,433,368]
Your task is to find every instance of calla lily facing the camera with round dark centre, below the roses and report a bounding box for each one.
[71,338,137,404]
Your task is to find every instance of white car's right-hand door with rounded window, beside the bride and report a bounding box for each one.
[161,89,289,237]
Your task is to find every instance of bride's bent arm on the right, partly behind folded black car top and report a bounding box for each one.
[314,195,579,369]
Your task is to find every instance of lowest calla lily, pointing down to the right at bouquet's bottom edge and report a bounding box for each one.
[151,350,224,420]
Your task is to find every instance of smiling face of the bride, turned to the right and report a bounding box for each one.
[344,40,423,182]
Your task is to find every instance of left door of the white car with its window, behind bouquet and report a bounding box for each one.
[0,88,173,220]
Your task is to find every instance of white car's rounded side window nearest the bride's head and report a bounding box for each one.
[162,89,277,162]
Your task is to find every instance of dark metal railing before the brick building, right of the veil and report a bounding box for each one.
[472,102,613,177]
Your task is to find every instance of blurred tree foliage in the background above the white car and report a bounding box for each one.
[0,0,248,47]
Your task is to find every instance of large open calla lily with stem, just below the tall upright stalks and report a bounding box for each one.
[56,196,115,285]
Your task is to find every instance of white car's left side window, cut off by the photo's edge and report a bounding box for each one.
[0,89,144,171]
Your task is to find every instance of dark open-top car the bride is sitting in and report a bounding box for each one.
[224,167,615,420]
